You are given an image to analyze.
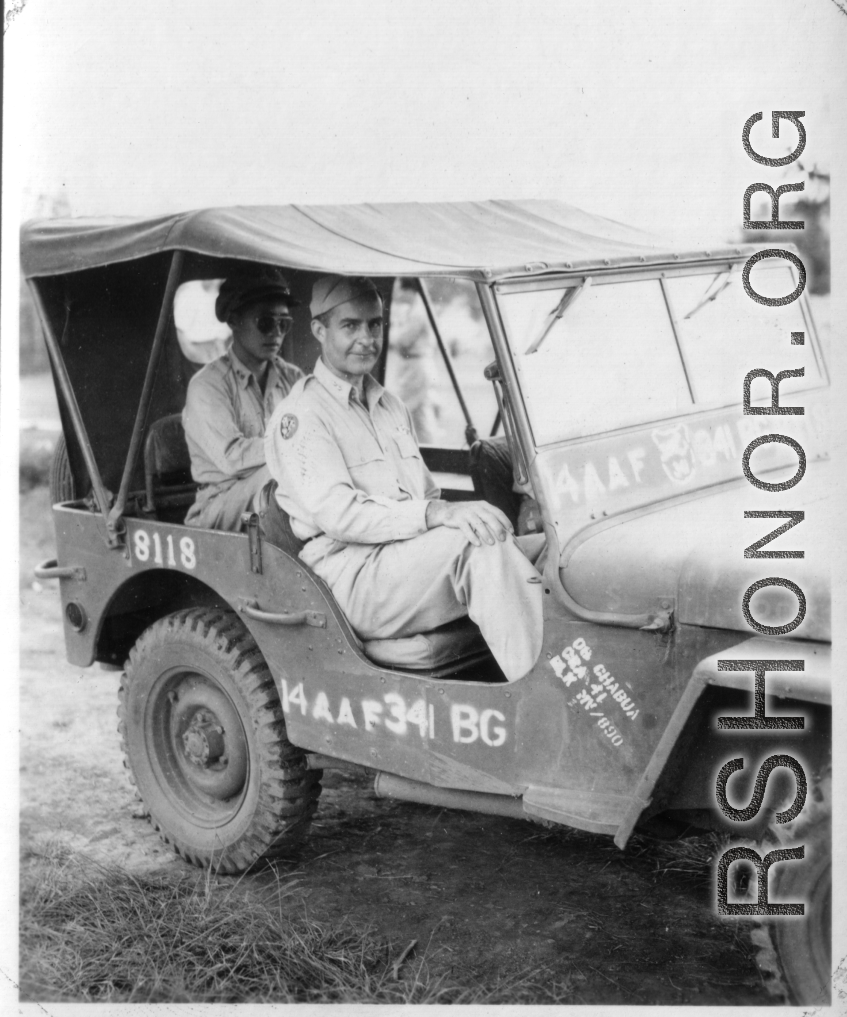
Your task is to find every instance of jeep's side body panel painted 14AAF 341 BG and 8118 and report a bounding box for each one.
[49,506,810,834]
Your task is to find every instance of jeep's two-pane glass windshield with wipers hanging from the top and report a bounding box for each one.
[497,261,825,445]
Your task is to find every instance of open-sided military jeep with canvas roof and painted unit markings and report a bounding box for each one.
[22,201,831,1003]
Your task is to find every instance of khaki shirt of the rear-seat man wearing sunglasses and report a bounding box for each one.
[182,350,303,490]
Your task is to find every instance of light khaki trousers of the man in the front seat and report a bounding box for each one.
[303,527,544,681]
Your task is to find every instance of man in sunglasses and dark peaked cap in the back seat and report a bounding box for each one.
[182,264,303,530]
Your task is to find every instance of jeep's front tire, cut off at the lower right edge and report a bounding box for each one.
[770,775,832,1006]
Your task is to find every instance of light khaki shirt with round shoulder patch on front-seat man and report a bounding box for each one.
[264,360,440,564]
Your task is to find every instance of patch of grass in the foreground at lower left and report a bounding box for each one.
[20,847,573,1004]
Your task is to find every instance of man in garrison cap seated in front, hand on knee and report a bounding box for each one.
[265,276,543,680]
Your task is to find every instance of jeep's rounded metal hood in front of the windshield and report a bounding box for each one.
[560,462,833,641]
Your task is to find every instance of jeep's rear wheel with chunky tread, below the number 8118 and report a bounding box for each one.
[118,608,321,873]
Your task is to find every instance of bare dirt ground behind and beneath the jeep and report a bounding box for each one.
[20,477,776,1005]
